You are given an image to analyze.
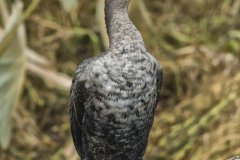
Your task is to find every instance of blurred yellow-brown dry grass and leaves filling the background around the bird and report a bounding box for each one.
[0,0,240,160]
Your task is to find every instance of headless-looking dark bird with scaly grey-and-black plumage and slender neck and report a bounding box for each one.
[69,0,163,160]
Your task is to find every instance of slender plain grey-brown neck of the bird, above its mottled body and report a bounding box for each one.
[105,4,145,49]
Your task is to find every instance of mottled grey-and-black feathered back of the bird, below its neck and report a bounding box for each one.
[69,51,159,160]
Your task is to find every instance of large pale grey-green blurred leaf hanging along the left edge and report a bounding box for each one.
[0,2,25,148]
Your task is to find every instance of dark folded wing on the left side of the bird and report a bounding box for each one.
[69,58,95,156]
